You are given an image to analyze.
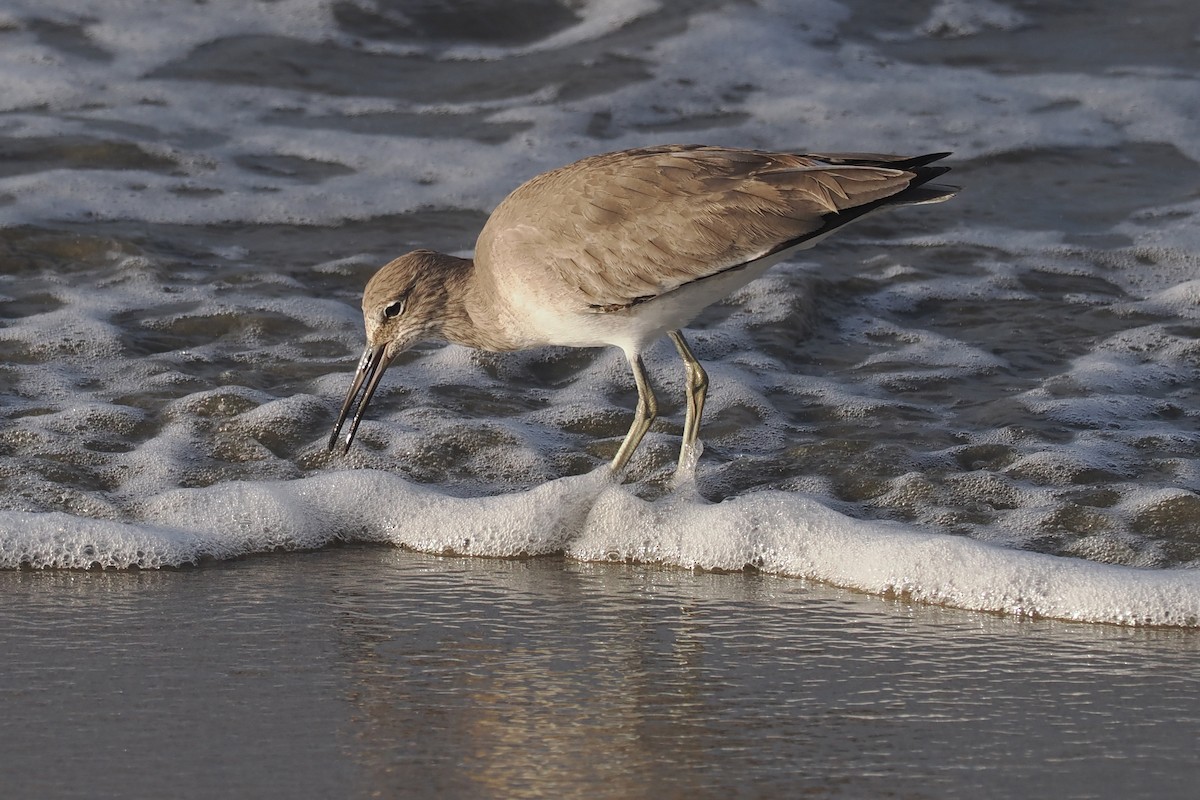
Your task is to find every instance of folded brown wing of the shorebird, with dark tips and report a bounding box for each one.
[476,146,944,311]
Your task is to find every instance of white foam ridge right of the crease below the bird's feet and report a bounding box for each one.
[569,492,1200,626]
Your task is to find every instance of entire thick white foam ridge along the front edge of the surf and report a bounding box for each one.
[0,469,1200,627]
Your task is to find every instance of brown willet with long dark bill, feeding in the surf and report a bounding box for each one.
[329,145,956,473]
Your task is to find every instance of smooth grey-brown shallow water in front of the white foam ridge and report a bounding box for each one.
[0,547,1200,799]
